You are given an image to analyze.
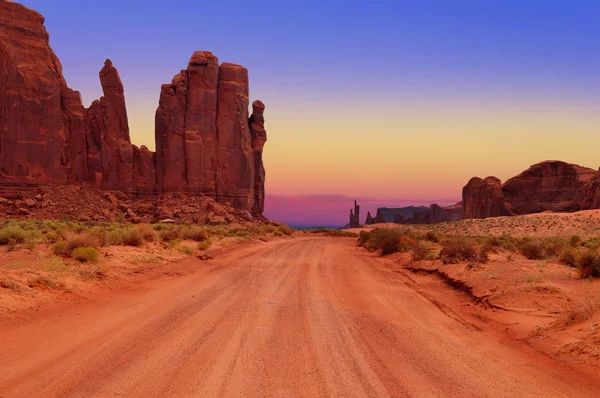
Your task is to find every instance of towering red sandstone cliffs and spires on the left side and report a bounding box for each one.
[0,0,267,215]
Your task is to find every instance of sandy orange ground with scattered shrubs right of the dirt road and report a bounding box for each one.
[357,218,600,363]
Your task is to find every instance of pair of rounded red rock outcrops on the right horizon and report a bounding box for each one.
[463,160,600,218]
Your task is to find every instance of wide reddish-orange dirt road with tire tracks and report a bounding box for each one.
[0,237,600,397]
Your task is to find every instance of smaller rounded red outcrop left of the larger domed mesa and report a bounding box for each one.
[462,177,507,218]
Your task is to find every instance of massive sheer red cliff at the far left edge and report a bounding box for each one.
[0,1,86,184]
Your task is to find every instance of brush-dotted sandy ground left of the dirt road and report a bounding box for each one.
[0,220,294,310]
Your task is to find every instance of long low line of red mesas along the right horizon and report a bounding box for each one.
[354,160,600,224]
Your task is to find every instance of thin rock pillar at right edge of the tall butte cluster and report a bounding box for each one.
[248,100,267,215]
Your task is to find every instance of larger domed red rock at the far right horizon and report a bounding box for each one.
[502,161,596,214]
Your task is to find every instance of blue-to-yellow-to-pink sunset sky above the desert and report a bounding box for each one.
[21,0,600,226]
